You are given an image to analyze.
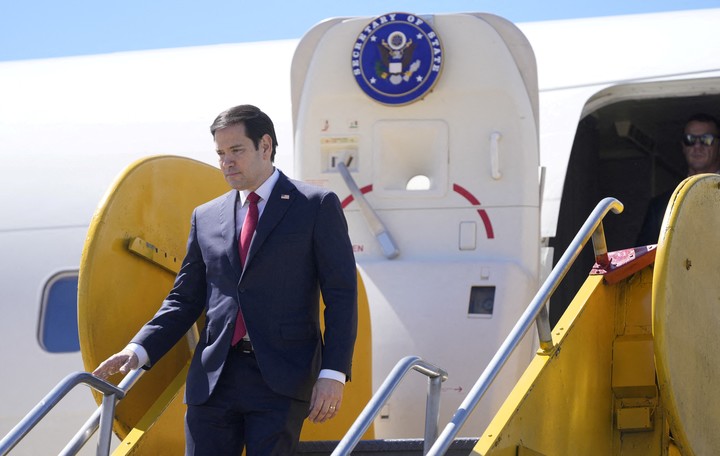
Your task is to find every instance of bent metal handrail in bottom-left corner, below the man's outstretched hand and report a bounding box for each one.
[0,372,125,456]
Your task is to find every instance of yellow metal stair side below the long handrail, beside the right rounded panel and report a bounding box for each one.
[473,268,668,456]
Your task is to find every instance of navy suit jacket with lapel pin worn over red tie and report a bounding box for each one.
[132,173,357,405]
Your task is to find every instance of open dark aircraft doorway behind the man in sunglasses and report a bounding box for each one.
[550,78,720,324]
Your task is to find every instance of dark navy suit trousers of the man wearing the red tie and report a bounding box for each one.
[185,350,309,456]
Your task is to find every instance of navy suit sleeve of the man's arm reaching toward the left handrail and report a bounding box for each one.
[131,212,206,366]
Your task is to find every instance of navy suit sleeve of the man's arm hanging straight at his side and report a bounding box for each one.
[313,193,358,379]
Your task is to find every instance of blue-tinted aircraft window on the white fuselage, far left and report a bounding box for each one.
[38,271,80,353]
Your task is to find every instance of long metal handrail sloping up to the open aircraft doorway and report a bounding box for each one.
[427,198,623,456]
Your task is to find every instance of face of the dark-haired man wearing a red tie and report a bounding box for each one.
[215,124,273,191]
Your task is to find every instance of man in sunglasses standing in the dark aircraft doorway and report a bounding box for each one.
[635,113,720,245]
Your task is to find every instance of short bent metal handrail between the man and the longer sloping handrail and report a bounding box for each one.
[331,356,448,456]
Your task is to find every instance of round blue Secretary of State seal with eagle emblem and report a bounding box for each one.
[352,13,442,105]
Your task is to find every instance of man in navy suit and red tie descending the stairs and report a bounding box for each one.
[93,105,357,456]
